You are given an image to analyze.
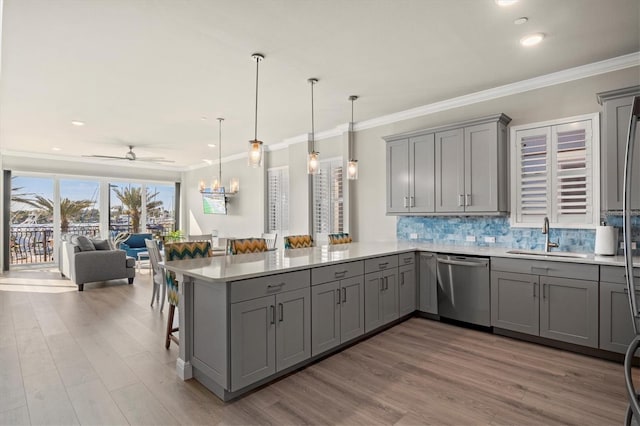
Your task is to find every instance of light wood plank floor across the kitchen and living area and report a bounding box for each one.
[0,271,640,425]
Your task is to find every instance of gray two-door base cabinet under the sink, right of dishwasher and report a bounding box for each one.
[491,258,599,348]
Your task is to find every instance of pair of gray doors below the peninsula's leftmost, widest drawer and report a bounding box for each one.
[230,288,311,391]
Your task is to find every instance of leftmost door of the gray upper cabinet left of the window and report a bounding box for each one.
[387,139,409,213]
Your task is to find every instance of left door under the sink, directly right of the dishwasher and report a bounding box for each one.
[491,271,540,336]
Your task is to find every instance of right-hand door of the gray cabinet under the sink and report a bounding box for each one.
[540,277,598,348]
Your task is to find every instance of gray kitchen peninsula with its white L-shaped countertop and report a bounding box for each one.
[165,242,640,401]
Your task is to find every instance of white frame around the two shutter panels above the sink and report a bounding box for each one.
[510,113,600,229]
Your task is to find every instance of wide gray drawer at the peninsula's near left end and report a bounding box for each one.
[229,270,311,303]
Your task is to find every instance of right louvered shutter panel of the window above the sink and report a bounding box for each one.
[552,121,594,223]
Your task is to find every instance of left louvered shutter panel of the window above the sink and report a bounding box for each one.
[516,128,551,222]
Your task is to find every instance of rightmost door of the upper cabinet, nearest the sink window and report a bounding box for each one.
[464,123,499,212]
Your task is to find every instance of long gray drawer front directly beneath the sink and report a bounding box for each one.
[491,257,598,281]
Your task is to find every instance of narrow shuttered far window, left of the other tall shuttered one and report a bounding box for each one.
[267,167,289,233]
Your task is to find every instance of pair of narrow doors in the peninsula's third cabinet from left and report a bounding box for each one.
[364,268,398,333]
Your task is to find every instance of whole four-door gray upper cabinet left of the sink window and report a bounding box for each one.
[384,114,511,215]
